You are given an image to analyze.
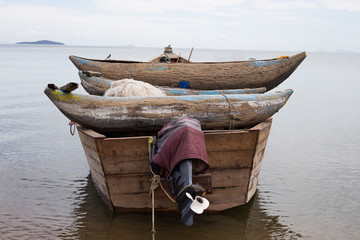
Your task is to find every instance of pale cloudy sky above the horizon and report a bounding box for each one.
[0,0,360,53]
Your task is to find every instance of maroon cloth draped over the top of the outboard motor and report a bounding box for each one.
[153,118,209,176]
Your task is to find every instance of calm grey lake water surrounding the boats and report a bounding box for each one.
[0,45,360,240]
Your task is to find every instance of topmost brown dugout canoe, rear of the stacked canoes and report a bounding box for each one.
[69,52,306,90]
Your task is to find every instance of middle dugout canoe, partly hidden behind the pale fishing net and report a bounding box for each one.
[79,71,266,96]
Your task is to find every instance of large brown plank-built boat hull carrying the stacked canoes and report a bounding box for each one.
[77,119,272,211]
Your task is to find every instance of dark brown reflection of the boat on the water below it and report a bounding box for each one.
[58,175,302,240]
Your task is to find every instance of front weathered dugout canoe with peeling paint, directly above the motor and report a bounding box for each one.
[44,87,293,132]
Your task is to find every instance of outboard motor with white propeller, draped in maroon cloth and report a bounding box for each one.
[150,117,209,226]
